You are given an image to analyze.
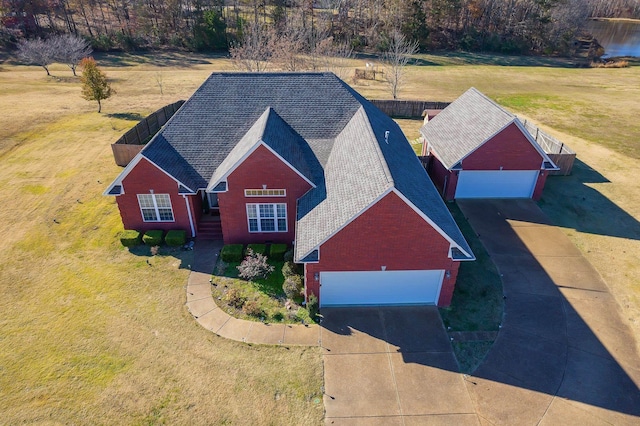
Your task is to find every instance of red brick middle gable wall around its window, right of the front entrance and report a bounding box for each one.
[218,146,311,244]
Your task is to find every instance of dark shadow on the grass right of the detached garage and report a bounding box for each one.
[539,159,640,240]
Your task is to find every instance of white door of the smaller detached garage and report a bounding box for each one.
[456,170,538,198]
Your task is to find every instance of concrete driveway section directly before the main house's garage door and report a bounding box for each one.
[320,306,479,425]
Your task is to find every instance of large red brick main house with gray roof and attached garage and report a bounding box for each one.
[105,73,474,306]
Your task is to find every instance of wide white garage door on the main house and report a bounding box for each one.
[320,270,444,306]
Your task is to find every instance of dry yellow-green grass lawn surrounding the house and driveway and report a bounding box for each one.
[0,50,640,425]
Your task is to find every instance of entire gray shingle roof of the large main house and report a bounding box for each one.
[112,73,473,259]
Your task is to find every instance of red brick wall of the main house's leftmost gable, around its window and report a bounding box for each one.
[116,158,194,235]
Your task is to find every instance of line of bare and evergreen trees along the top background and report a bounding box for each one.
[0,0,640,54]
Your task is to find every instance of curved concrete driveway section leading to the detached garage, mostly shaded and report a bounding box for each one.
[458,200,640,425]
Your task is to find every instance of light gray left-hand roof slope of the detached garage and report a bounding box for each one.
[420,87,516,169]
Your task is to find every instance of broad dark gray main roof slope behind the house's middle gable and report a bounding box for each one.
[143,73,359,190]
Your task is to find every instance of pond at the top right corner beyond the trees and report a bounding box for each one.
[586,20,640,57]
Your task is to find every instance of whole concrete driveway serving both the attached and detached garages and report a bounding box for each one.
[320,200,640,425]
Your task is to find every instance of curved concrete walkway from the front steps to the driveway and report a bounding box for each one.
[186,240,320,346]
